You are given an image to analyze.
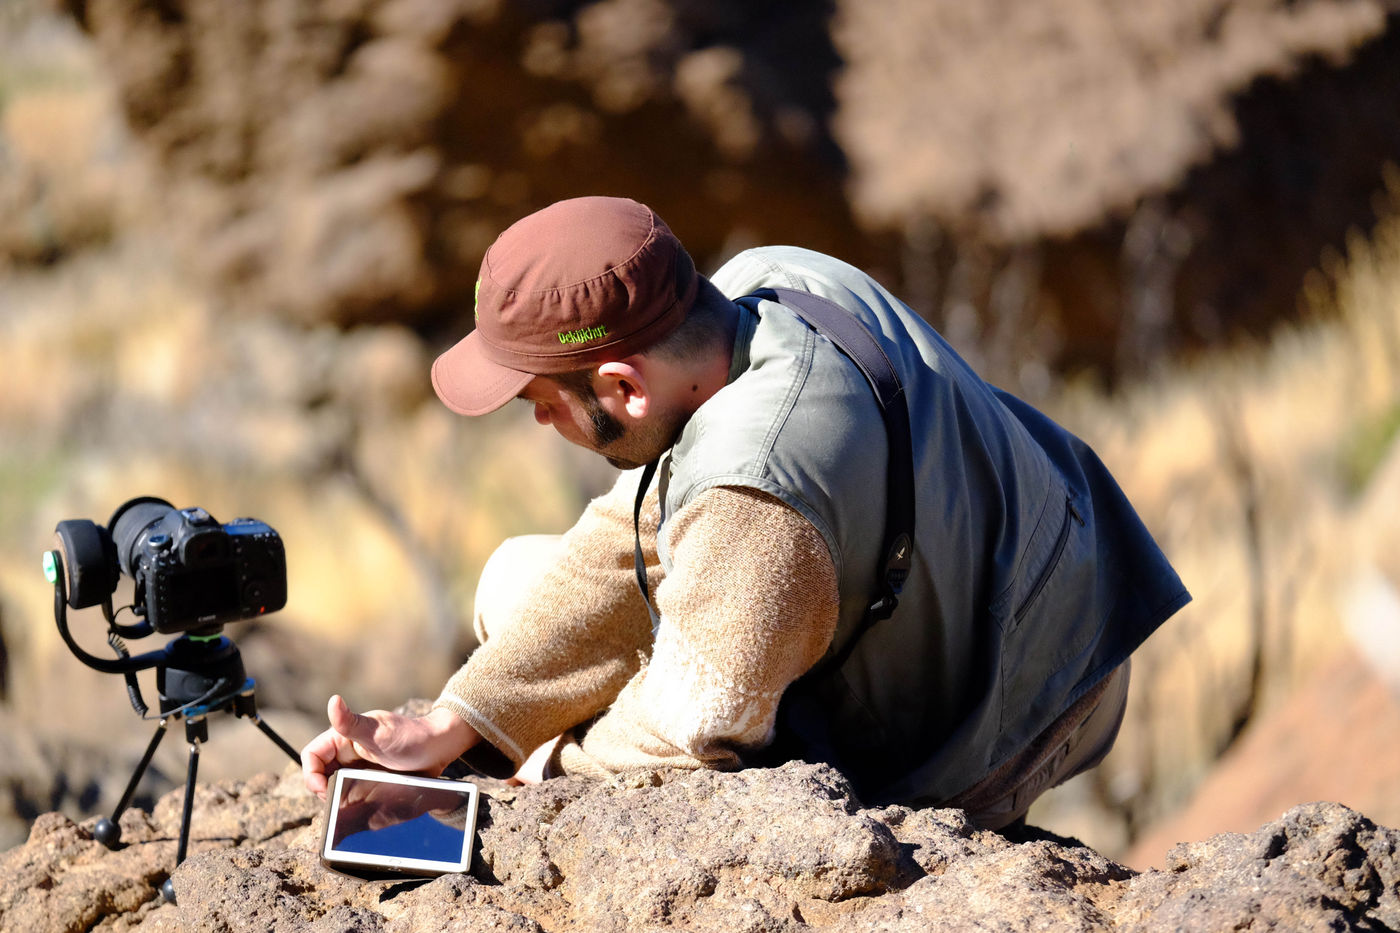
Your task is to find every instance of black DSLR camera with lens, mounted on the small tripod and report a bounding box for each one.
[46,496,287,633]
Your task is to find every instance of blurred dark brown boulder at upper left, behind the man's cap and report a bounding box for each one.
[60,0,871,332]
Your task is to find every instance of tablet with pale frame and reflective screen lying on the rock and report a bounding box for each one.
[321,768,477,874]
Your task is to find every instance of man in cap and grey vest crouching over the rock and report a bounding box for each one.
[302,191,1190,828]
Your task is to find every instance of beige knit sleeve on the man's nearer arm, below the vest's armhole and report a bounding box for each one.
[552,488,837,776]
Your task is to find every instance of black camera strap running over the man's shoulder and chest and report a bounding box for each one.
[633,289,914,667]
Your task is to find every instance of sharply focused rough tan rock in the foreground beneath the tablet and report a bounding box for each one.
[0,763,1400,933]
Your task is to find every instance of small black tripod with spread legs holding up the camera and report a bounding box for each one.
[92,635,301,904]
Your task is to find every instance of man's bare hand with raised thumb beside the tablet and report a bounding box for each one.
[301,696,482,800]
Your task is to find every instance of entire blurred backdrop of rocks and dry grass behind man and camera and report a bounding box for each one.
[0,0,1400,867]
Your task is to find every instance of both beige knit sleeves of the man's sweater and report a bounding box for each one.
[435,474,837,778]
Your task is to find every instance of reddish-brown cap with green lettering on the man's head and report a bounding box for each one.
[433,198,697,415]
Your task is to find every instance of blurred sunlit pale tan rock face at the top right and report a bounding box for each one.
[836,0,1387,240]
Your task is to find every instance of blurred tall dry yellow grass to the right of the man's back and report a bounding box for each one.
[1037,167,1400,852]
